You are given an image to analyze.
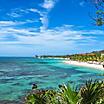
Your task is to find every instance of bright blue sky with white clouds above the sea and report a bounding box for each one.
[0,0,104,56]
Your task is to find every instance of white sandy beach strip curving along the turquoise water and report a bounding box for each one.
[64,60,104,71]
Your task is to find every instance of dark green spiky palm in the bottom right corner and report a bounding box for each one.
[80,81,104,104]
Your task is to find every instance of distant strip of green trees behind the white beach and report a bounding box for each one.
[41,50,104,64]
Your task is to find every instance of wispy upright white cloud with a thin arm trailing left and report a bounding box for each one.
[7,0,56,32]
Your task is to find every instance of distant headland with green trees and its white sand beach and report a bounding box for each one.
[36,50,104,70]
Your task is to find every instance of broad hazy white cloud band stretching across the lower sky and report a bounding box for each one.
[0,22,104,53]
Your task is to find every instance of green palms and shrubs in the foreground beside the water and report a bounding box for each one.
[26,81,104,104]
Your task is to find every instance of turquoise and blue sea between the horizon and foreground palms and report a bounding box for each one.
[0,57,104,100]
